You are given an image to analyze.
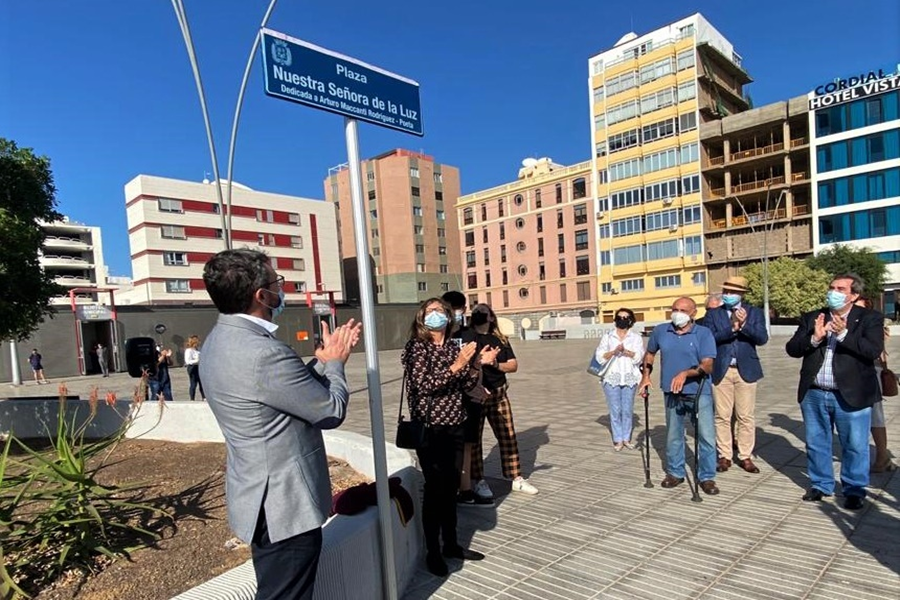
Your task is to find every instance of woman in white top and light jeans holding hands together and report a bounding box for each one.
[596,308,644,452]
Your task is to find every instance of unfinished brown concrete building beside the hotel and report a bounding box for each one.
[700,96,813,291]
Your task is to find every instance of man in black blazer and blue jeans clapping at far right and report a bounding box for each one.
[786,273,884,510]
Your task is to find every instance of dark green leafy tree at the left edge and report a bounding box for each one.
[0,138,62,341]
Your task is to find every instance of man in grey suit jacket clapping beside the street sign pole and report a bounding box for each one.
[200,249,361,600]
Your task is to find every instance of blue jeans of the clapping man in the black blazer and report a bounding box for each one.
[800,390,872,498]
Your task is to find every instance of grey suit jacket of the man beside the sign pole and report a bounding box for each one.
[200,315,350,543]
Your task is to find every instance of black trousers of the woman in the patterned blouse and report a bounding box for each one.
[416,425,463,554]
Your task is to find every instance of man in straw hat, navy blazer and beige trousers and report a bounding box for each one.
[703,277,769,473]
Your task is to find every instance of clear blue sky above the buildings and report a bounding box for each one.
[0,0,900,275]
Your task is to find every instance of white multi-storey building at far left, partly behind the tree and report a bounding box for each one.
[38,217,109,306]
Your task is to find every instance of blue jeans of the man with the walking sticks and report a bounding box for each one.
[666,386,716,481]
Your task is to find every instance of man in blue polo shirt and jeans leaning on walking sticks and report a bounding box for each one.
[638,297,719,495]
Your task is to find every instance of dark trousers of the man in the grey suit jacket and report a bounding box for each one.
[250,508,322,600]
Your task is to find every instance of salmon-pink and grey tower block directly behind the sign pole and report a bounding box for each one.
[324,149,461,304]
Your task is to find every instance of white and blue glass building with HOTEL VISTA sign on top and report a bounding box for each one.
[807,67,900,316]
